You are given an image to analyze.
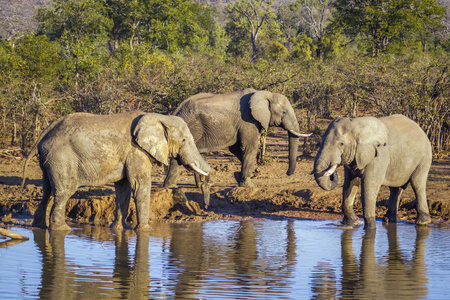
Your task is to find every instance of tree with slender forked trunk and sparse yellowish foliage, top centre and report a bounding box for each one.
[227,0,276,62]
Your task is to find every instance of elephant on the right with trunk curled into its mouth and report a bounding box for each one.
[313,115,432,229]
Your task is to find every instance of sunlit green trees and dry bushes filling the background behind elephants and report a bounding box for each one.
[0,0,450,155]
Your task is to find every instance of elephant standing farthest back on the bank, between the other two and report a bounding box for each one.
[164,89,309,206]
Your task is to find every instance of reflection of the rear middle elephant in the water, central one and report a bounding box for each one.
[168,221,296,299]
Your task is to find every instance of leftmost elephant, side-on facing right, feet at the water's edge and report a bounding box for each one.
[22,111,210,230]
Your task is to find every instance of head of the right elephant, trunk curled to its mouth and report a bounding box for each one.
[313,117,388,191]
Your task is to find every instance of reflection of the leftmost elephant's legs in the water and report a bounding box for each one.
[33,227,150,299]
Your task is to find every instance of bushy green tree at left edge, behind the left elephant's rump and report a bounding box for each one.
[0,34,61,149]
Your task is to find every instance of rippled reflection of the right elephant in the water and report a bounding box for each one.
[312,224,430,299]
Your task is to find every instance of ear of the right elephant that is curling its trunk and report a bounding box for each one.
[353,117,388,170]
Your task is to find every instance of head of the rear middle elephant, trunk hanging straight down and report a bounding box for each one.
[249,91,311,175]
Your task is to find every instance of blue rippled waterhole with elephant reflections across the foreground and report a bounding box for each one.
[0,220,450,299]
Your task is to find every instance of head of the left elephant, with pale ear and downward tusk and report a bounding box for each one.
[133,113,211,176]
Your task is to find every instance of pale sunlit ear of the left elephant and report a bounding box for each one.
[133,114,169,165]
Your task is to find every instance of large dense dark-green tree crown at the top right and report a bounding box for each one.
[333,0,444,55]
